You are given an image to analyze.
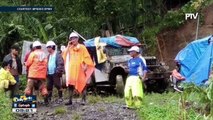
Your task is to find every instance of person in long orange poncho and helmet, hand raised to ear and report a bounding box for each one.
[62,32,94,105]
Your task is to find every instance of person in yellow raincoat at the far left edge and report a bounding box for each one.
[0,62,16,94]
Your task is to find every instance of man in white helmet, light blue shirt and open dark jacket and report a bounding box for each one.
[46,41,64,103]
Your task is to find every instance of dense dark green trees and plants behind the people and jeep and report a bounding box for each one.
[0,0,211,60]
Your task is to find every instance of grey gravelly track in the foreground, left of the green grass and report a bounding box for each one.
[17,96,138,120]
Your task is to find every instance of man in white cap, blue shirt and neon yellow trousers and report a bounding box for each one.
[124,46,147,108]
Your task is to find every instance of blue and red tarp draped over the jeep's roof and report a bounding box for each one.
[84,35,141,47]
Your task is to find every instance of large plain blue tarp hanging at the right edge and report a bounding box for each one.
[175,35,213,85]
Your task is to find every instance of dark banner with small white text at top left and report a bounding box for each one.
[0,6,54,12]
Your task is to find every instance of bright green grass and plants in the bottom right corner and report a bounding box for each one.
[138,79,213,120]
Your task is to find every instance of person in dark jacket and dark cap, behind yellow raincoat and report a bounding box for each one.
[3,45,22,97]
